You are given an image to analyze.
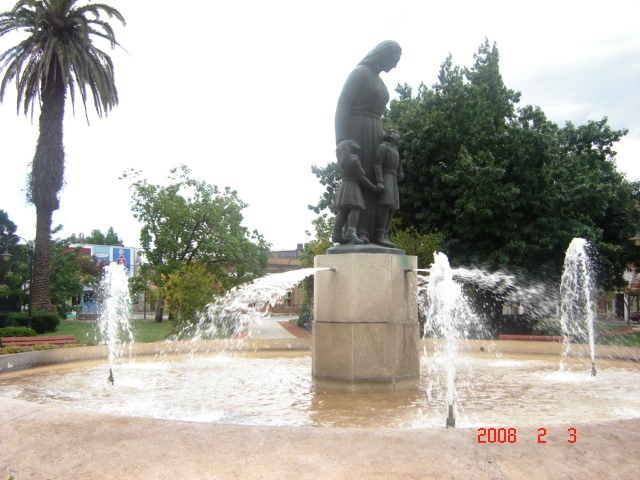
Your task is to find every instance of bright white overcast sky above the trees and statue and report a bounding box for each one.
[0,0,640,249]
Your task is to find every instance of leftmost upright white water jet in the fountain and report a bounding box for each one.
[98,262,133,385]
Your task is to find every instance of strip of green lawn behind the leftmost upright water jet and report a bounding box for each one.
[50,319,169,345]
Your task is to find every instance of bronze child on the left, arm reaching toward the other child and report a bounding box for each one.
[331,140,384,245]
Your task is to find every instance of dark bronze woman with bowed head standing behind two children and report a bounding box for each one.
[336,40,402,243]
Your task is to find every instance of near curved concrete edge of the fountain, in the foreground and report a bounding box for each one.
[0,397,640,480]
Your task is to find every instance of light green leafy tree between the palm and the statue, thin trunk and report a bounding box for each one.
[122,165,269,322]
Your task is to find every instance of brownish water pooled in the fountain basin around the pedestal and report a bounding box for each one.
[0,352,640,428]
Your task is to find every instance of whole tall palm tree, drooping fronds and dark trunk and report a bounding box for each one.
[0,0,125,311]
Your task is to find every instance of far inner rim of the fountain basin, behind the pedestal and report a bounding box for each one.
[0,338,640,375]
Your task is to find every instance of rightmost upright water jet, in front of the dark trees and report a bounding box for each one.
[560,238,596,376]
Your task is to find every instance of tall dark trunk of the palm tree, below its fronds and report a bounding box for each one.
[29,61,66,312]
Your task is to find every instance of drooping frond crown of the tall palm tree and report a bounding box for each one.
[0,0,125,120]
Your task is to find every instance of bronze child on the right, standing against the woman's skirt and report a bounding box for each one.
[373,130,402,248]
